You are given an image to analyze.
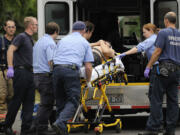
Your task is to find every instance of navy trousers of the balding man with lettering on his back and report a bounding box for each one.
[146,72,179,132]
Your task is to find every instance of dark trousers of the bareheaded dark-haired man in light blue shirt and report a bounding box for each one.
[34,73,54,130]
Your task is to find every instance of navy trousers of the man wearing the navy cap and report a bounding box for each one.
[53,66,81,130]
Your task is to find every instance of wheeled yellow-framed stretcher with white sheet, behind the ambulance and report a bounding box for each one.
[67,57,127,134]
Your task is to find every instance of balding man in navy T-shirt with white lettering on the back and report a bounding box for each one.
[142,12,180,135]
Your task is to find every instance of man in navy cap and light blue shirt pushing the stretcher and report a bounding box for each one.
[52,21,94,135]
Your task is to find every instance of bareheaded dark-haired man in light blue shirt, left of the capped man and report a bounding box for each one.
[33,22,60,135]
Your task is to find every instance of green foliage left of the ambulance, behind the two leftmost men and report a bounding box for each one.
[0,0,37,33]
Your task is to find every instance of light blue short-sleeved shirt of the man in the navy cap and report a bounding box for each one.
[53,32,94,67]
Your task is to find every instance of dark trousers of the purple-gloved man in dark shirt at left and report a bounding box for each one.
[5,69,35,131]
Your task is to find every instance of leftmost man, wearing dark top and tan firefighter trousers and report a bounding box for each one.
[0,20,16,130]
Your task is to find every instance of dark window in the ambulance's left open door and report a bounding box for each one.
[45,2,70,35]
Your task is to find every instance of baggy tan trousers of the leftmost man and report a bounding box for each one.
[0,70,13,122]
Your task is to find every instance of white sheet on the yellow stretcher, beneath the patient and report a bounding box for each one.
[80,58,124,81]
